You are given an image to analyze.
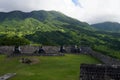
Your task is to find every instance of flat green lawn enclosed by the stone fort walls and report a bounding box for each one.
[0,55,100,80]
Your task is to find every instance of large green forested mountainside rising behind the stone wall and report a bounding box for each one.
[0,10,120,58]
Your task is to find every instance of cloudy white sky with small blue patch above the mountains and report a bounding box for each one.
[0,0,120,24]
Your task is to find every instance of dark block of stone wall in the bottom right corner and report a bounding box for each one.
[80,64,120,80]
